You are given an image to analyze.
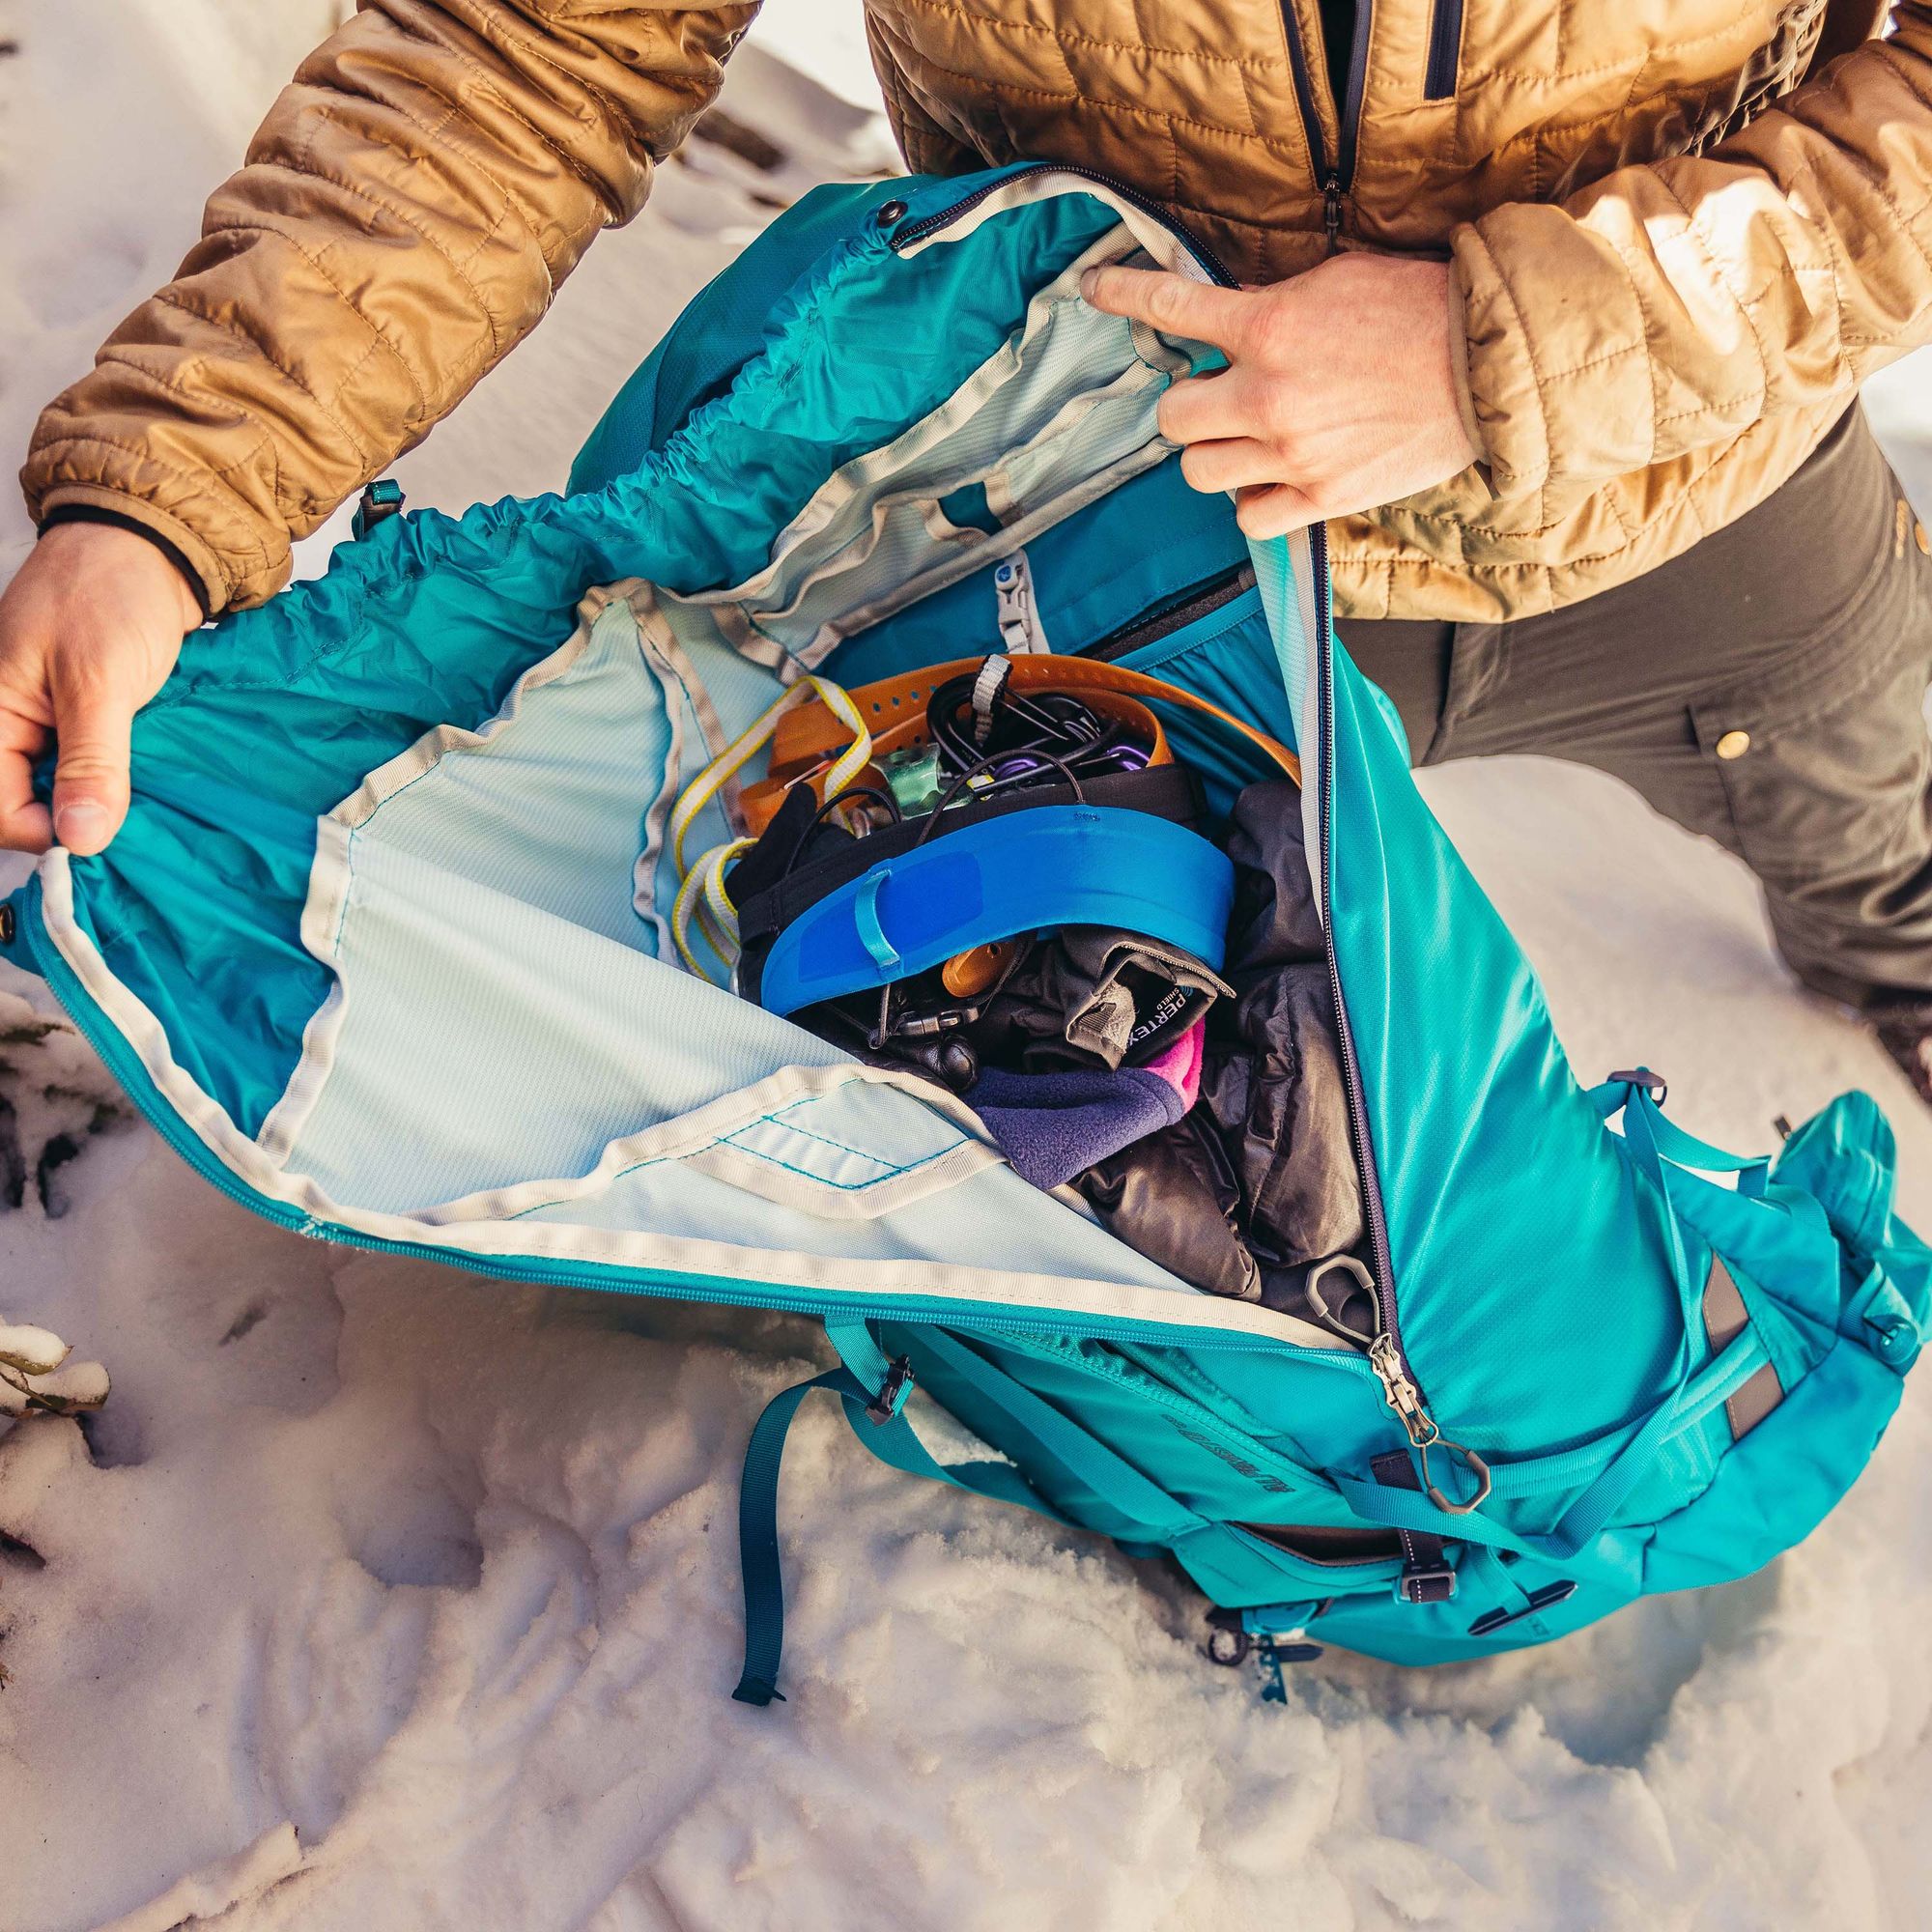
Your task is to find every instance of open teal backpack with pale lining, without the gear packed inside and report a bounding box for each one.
[0,166,1932,1702]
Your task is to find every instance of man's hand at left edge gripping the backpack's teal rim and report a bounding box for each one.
[0,524,201,854]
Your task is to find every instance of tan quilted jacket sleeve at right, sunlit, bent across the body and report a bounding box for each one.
[1453,0,1932,493]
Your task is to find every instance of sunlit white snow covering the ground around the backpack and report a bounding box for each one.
[0,0,1932,1932]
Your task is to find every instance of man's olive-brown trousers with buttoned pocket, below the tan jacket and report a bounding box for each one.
[1339,406,1932,1007]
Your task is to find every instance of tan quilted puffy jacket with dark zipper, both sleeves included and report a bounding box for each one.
[23,0,1932,618]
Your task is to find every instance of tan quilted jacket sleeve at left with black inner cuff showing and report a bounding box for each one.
[21,0,757,611]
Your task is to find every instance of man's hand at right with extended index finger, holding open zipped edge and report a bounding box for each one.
[1082,255,1482,537]
